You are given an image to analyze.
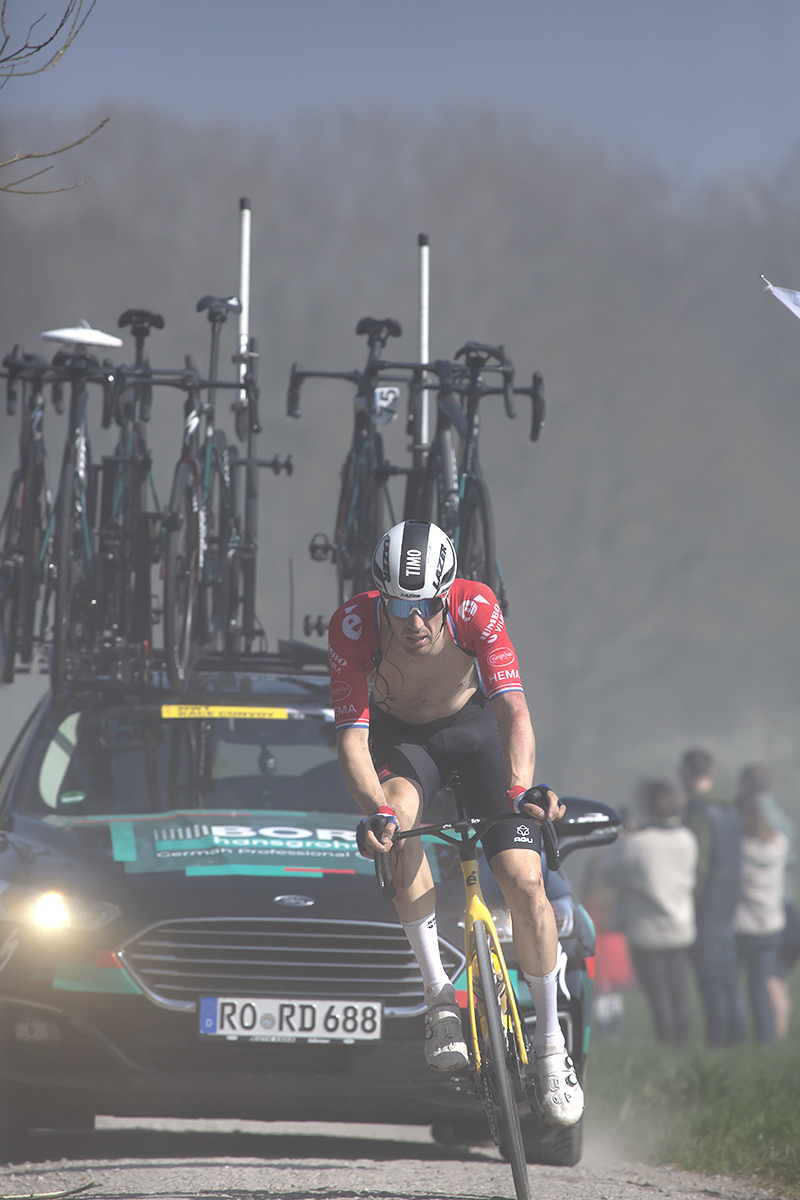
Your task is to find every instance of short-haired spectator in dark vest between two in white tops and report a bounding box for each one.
[679,750,746,1046]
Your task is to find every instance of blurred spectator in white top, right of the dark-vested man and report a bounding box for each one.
[733,766,789,1043]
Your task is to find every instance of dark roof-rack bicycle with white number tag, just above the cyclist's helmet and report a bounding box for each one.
[287,317,419,604]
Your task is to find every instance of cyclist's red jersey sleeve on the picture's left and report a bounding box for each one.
[327,593,378,730]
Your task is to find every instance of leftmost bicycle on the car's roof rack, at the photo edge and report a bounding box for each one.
[0,346,53,683]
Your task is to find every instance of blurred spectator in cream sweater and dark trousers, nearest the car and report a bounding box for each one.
[603,779,697,1045]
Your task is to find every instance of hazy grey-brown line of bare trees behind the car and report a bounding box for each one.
[0,109,800,804]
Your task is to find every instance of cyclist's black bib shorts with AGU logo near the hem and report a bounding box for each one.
[369,691,542,862]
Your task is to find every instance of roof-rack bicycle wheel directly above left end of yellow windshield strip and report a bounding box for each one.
[163,461,205,691]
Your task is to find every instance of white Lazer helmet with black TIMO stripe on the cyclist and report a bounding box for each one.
[372,521,456,617]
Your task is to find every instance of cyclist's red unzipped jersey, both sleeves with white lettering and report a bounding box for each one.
[327,580,523,730]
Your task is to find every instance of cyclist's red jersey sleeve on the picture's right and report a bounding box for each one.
[450,580,523,700]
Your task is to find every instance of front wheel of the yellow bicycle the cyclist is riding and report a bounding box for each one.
[473,920,530,1200]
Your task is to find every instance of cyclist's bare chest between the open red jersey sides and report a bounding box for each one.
[372,630,479,725]
